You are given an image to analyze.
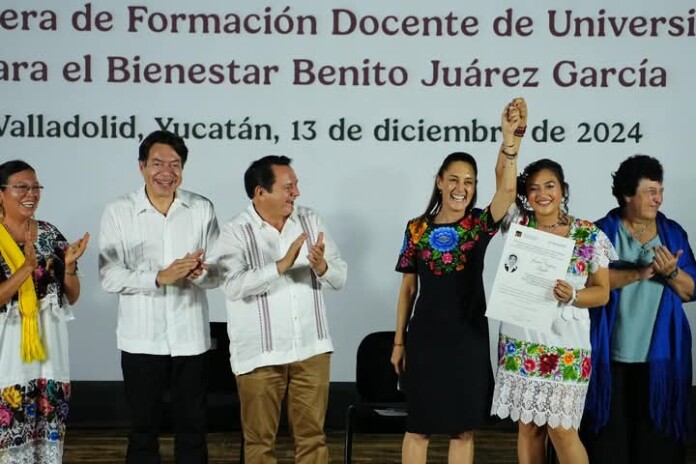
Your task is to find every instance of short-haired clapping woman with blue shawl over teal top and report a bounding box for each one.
[584,155,696,464]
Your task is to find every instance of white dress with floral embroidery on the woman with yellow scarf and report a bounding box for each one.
[0,221,73,464]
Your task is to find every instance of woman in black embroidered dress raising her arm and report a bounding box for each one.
[391,99,527,464]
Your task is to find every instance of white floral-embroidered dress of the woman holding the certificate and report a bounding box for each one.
[491,211,615,429]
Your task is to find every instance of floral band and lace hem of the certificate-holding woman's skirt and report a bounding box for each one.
[491,334,591,429]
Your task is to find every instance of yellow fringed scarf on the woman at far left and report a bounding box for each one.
[0,225,46,363]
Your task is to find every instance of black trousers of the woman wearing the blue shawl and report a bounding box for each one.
[582,362,686,464]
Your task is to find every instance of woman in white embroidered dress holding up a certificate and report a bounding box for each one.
[492,159,613,464]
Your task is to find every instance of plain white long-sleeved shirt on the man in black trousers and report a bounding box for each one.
[99,188,219,356]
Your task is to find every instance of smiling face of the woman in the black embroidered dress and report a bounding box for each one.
[437,161,476,216]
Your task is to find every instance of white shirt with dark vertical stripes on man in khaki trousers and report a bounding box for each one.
[213,205,347,374]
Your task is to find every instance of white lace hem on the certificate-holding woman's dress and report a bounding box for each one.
[491,369,587,429]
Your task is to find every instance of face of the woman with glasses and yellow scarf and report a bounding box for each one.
[0,169,41,221]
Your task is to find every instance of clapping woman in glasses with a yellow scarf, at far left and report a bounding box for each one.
[0,160,89,463]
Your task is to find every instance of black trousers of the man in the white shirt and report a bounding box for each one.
[121,351,208,464]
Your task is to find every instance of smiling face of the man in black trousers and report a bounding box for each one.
[140,143,183,202]
